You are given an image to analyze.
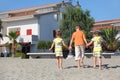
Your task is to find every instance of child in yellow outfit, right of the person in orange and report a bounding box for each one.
[87,31,103,69]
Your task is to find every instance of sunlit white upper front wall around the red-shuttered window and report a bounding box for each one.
[7,19,38,35]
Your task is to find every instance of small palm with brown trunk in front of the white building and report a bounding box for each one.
[7,31,19,57]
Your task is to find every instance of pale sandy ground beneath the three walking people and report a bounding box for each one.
[0,56,120,80]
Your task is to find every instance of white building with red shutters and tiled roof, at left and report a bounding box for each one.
[0,2,70,52]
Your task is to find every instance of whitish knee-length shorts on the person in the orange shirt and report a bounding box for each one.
[75,46,85,60]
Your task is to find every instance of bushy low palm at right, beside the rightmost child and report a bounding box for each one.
[101,27,120,51]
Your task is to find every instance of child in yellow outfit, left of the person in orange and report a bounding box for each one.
[49,30,68,69]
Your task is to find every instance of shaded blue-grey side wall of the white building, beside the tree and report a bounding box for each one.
[38,13,58,41]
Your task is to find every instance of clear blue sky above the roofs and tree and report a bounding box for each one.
[0,0,120,22]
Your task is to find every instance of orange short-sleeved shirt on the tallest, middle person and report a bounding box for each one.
[72,31,85,46]
